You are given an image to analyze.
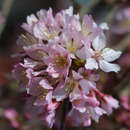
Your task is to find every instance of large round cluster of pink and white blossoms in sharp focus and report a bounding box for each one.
[13,7,121,127]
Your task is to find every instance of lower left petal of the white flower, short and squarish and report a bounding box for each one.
[85,58,98,70]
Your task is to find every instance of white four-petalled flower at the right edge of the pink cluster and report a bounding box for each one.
[85,33,121,72]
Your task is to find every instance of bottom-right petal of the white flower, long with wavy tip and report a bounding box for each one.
[99,60,120,72]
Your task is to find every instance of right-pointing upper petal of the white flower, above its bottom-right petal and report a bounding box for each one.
[102,48,121,62]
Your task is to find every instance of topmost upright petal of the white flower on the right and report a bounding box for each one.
[92,33,106,51]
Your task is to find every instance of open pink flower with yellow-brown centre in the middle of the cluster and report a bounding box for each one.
[44,44,71,78]
